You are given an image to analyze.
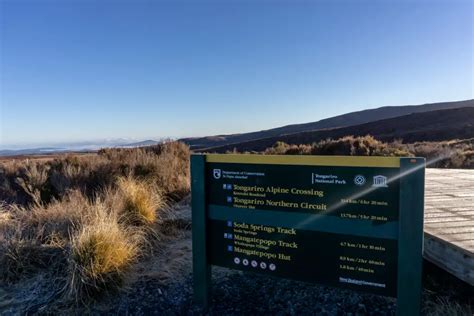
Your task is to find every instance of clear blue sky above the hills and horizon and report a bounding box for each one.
[0,0,474,147]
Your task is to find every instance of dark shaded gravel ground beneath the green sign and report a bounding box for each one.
[97,268,396,316]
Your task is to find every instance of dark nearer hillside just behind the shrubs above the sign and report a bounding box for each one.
[203,107,474,152]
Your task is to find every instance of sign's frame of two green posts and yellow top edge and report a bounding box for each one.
[191,154,425,315]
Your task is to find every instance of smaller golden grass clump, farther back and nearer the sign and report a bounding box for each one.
[117,177,165,225]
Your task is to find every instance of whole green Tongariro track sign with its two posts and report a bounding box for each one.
[192,155,424,315]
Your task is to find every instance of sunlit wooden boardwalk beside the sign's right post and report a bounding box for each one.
[424,169,474,285]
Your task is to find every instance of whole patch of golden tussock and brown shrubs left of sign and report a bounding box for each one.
[0,142,190,303]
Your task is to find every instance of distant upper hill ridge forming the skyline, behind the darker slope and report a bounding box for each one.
[180,99,474,149]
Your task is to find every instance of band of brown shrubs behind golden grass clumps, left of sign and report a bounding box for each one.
[0,142,190,206]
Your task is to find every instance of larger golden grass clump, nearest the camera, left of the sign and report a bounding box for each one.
[68,204,141,301]
